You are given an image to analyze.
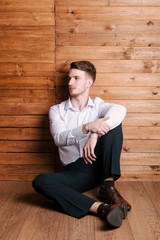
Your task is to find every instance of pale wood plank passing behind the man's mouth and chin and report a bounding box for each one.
[56,86,160,100]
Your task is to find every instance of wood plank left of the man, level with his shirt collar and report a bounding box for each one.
[0,101,55,116]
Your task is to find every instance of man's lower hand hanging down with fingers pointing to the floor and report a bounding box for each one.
[83,133,98,164]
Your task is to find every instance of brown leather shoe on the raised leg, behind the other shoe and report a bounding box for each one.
[99,185,131,211]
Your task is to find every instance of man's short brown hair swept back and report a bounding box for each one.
[70,61,96,82]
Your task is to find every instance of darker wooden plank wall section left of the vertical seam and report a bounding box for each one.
[0,0,55,180]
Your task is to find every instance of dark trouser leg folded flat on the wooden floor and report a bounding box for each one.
[33,158,95,218]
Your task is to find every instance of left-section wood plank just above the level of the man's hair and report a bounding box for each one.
[0,50,55,63]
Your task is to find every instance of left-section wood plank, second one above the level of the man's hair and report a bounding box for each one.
[0,36,55,51]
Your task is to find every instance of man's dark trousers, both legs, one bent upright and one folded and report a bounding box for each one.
[33,125,123,218]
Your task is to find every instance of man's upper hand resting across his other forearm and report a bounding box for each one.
[88,117,110,135]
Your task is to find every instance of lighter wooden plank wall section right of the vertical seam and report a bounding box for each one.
[56,0,160,180]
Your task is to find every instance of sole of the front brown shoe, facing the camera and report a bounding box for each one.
[106,203,128,228]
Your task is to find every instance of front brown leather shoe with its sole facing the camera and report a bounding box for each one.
[102,203,128,228]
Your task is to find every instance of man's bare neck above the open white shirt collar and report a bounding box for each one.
[70,95,89,111]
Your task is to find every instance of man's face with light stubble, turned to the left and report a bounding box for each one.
[68,69,93,97]
